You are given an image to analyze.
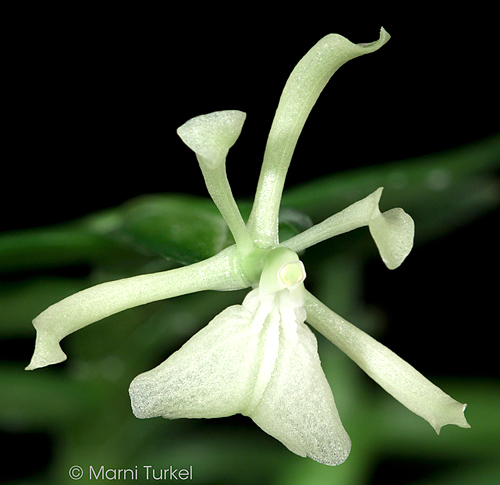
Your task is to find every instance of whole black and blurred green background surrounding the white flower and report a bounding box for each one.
[0,10,500,485]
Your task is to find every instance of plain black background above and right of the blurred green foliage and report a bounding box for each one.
[0,5,500,483]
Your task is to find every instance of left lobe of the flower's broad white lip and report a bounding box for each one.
[129,305,258,419]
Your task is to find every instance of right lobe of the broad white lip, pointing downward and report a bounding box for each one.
[244,310,351,465]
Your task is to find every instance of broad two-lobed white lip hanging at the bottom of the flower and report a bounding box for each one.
[129,258,351,465]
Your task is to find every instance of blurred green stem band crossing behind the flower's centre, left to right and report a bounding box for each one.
[0,136,494,271]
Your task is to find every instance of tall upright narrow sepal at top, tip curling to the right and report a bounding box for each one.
[248,29,390,247]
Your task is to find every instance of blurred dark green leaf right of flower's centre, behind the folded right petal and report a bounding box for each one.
[283,135,500,227]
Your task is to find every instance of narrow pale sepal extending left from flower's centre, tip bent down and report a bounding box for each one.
[26,246,248,370]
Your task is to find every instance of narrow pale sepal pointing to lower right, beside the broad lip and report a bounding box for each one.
[305,293,470,434]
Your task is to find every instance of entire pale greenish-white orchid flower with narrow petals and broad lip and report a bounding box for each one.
[27,29,469,465]
